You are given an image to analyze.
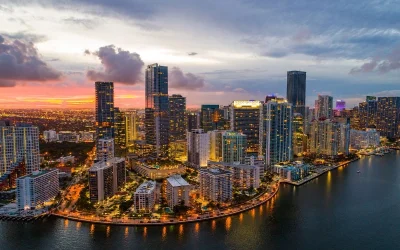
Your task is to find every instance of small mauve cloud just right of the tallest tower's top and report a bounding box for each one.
[168,67,204,90]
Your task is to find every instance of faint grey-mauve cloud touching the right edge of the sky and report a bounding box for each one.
[349,48,400,75]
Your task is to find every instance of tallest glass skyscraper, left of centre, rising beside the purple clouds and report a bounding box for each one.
[145,63,169,156]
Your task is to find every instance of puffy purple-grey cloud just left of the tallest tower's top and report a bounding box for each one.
[84,45,144,85]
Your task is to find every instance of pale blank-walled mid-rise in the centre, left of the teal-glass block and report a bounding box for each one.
[187,129,210,168]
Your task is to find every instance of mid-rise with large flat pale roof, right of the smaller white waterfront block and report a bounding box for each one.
[167,175,190,208]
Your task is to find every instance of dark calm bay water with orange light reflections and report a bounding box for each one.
[0,151,400,250]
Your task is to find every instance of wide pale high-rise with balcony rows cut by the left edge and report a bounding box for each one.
[0,121,40,176]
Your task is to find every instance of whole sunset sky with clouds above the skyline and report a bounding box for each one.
[0,0,400,108]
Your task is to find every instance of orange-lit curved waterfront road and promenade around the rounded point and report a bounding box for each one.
[51,182,279,226]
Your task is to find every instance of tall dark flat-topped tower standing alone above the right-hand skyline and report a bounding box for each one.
[286,71,306,117]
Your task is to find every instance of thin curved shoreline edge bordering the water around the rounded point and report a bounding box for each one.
[51,183,280,226]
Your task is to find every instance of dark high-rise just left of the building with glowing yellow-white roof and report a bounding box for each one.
[200,104,225,132]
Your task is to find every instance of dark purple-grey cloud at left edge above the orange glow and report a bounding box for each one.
[0,36,62,87]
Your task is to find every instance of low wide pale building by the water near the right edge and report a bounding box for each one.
[350,128,380,149]
